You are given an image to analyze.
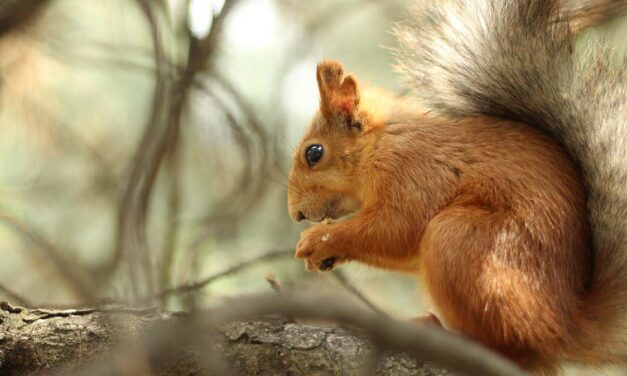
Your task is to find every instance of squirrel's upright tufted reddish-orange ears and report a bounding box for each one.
[316,61,359,126]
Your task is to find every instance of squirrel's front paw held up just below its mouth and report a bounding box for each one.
[295,225,346,272]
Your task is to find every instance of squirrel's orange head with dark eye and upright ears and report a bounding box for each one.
[288,61,368,222]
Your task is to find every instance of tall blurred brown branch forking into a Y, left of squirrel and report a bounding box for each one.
[114,0,243,299]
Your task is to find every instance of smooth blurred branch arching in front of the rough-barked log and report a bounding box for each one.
[195,293,525,376]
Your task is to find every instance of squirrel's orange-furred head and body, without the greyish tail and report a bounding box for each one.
[288,62,592,373]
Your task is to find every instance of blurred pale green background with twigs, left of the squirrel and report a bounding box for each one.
[0,0,423,317]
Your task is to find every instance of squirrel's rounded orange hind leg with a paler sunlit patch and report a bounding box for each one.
[420,206,576,374]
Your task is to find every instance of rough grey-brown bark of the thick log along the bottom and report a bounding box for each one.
[0,302,451,376]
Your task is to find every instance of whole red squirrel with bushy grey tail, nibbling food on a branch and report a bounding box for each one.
[288,0,627,374]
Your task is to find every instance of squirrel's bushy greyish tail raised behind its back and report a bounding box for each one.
[396,0,627,361]
